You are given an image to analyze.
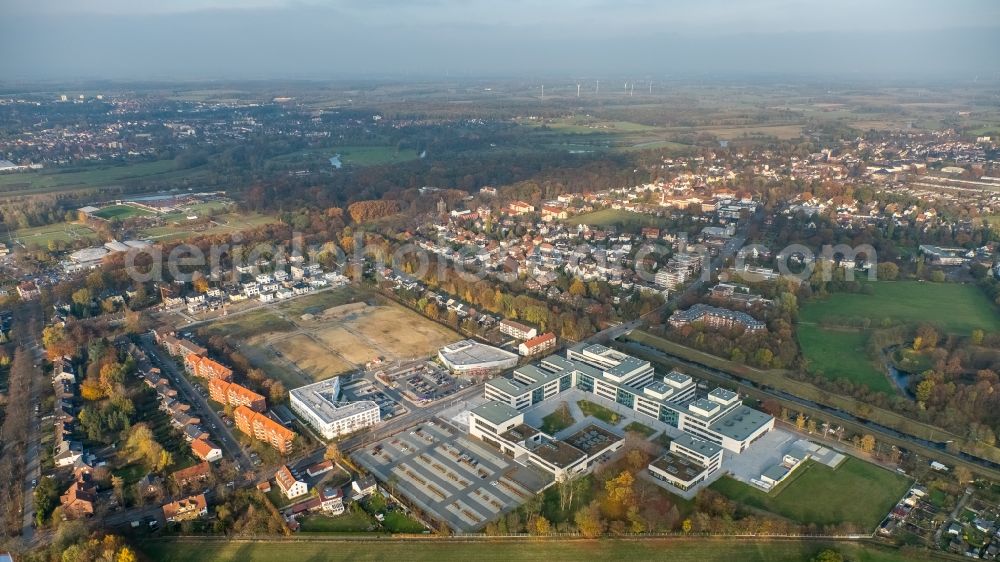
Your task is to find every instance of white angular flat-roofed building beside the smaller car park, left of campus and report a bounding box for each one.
[289,377,382,439]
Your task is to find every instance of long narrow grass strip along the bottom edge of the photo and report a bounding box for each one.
[138,538,934,562]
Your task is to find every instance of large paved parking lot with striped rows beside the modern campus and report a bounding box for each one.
[352,420,552,532]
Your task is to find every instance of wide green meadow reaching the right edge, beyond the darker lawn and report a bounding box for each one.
[799,281,1000,335]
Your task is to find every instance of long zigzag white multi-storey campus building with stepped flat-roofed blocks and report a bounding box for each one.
[484,344,774,453]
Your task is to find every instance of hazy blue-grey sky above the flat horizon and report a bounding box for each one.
[0,0,1000,81]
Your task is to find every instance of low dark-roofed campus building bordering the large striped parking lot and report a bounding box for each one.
[469,401,624,481]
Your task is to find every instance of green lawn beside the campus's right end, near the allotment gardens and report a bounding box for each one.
[711,457,910,530]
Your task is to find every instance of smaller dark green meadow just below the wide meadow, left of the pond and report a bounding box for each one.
[798,325,895,394]
